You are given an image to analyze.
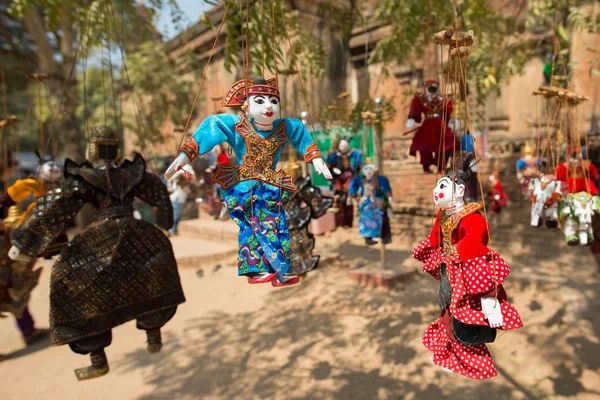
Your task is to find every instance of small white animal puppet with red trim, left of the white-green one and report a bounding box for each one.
[524,174,568,228]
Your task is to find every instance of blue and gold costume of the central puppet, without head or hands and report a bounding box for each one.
[182,112,321,280]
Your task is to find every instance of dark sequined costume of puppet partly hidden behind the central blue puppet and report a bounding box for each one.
[285,177,333,275]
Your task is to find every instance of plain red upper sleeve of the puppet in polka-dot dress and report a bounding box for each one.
[456,213,489,261]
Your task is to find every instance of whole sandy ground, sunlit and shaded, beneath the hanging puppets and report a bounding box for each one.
[0,208,600,400]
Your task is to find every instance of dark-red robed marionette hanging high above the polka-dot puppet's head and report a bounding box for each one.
[404,80,458,174]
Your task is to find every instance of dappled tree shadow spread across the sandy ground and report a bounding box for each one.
[113,202,600,400]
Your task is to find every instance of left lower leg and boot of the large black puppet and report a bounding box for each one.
[69,331,112,381]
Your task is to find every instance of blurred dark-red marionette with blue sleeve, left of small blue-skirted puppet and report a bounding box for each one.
[329,139,362,228]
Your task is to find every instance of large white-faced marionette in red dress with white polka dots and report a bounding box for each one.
[413,155,523,380]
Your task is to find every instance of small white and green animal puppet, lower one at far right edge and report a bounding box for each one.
[559,192,600,246]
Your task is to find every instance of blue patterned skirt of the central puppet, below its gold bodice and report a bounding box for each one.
[219,181,290,281]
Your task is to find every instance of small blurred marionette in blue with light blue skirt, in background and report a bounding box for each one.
[349,161,393,245]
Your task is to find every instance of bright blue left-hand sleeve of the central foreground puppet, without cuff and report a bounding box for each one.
[182,114,240,155]
